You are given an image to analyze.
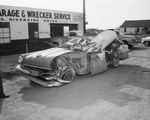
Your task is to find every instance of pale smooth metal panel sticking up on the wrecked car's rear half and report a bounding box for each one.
[91,30,117,50]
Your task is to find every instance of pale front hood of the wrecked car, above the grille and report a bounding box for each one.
[22,48,73,69]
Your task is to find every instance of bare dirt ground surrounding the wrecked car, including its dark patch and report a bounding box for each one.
[0,44,150,120]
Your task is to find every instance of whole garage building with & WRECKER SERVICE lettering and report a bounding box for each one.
[0,6,83,55]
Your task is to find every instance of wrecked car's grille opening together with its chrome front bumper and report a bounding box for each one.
[16,61,66,87]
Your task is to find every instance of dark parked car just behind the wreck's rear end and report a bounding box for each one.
[117,31,137,49]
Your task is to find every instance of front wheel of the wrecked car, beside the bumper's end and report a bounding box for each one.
[61,67,76,82]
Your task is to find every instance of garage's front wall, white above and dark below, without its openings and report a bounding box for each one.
[0,5,83,55]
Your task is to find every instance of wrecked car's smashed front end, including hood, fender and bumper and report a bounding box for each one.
[16,49,75,87]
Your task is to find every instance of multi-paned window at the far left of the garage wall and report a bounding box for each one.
[0,22,10,44]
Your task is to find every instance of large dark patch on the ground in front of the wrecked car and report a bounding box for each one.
[19,65,150,109]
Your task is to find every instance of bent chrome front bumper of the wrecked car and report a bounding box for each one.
[16,64,70,87]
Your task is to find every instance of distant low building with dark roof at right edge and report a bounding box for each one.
[119,20,150,34]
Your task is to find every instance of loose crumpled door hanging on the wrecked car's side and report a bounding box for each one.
[90,53,108,75]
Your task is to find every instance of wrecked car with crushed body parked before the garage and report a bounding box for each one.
[16,31,128,87]
